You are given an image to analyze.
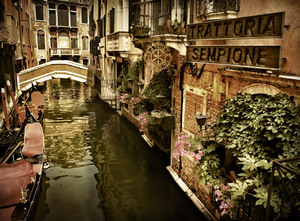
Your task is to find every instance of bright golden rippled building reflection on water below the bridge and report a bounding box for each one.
[45,79,95,167]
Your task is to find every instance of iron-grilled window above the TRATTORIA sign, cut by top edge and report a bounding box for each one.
[196,0,240,17]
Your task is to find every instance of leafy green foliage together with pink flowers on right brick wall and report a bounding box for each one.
[173,94,300,219]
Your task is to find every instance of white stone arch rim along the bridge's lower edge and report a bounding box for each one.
[20,71,87,91]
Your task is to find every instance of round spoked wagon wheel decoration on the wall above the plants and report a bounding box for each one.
[144,43,172,72]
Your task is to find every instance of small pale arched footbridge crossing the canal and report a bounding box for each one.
[17,60,88,91]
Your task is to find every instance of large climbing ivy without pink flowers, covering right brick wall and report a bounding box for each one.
[214,93,300,218]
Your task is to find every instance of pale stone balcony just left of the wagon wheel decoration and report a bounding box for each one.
[107,32,131,53]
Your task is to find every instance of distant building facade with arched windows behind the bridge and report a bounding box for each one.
[30,0,90,65]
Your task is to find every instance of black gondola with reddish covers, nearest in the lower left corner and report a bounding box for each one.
[0,102,44,221]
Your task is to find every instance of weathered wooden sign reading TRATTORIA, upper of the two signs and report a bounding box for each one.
[187,12,284,41]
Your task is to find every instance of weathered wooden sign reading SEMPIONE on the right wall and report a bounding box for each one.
[187,45,281,70]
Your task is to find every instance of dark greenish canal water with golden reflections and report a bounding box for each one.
[34,79,205,221]
